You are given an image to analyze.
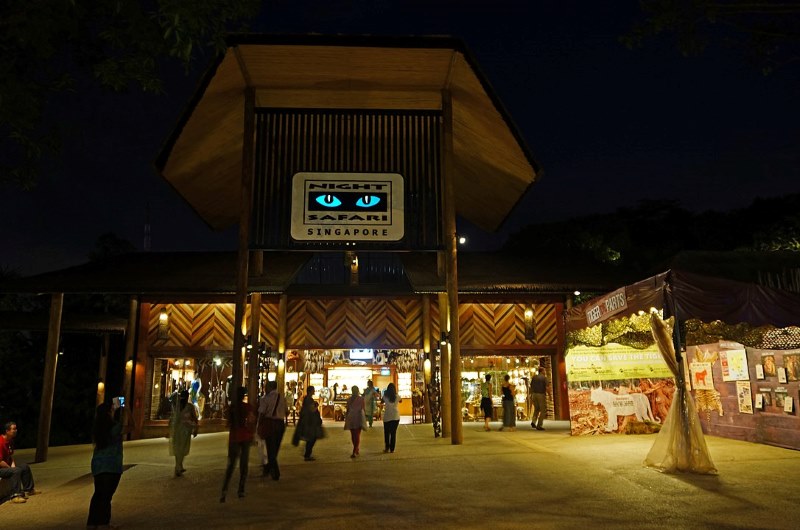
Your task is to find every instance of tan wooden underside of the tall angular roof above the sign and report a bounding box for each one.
[157,35,539,231]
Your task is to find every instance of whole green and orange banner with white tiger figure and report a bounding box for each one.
[566,344,675,435]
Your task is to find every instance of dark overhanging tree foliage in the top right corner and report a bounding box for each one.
[621,0,800,74]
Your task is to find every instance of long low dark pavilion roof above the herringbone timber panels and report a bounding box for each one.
[0,252,625,294]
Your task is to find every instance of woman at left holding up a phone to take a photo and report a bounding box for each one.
[86,398,129,529]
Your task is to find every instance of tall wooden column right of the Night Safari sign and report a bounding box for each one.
[442,89,464,445]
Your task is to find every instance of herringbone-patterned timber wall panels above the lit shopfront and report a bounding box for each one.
[147,296,558,351]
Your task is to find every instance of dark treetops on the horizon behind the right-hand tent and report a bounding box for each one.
[504,194,800,276]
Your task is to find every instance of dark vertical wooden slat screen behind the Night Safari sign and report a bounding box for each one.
[250,108,442,250]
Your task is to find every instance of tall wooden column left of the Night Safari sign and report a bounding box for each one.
[231,87,256,420]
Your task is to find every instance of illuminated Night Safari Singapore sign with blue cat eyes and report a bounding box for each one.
[291,173,404,242]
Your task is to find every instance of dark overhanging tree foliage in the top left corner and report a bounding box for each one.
[0,0,261,188]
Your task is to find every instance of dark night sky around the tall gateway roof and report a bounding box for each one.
[0,0,800,274]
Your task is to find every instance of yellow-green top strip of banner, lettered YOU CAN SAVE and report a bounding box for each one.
[566,344,672,382]
